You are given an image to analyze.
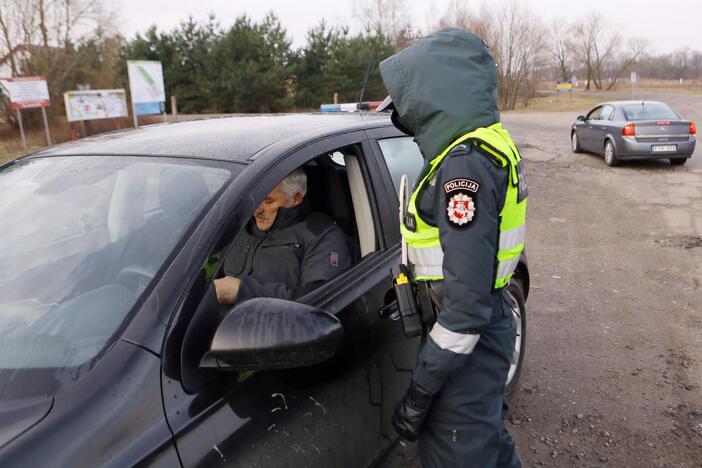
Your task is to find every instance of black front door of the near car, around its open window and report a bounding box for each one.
[162,131,409,467]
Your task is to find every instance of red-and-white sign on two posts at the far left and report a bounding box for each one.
[0,76,51,153]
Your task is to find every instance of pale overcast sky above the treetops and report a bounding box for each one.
[110,0,702,53]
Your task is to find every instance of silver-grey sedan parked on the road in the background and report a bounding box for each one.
[570,101,696,166]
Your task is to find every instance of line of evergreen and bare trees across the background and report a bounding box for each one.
[0,0,702,117]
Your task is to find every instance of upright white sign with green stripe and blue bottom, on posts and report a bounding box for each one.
[127,60,166,128]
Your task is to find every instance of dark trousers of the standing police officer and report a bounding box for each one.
[419,292,521,468]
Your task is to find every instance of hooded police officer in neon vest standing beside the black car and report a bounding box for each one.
[380,29,527,467]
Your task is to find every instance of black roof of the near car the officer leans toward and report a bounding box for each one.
[29,112,392,162]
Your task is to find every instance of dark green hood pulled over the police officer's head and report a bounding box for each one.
[380,28,500,161]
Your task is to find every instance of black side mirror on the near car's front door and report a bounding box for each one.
[200,298,343,370]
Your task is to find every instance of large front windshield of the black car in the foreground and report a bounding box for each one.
[0,156,232,396]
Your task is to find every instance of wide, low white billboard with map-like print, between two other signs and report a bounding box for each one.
[63,89,128,122]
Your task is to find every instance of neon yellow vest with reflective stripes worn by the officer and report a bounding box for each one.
[400,122,527,289]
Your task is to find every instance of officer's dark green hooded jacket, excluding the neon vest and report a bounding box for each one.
[380,29,514,394]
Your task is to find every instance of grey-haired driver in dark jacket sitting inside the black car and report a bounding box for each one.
[214,168,352,304]
